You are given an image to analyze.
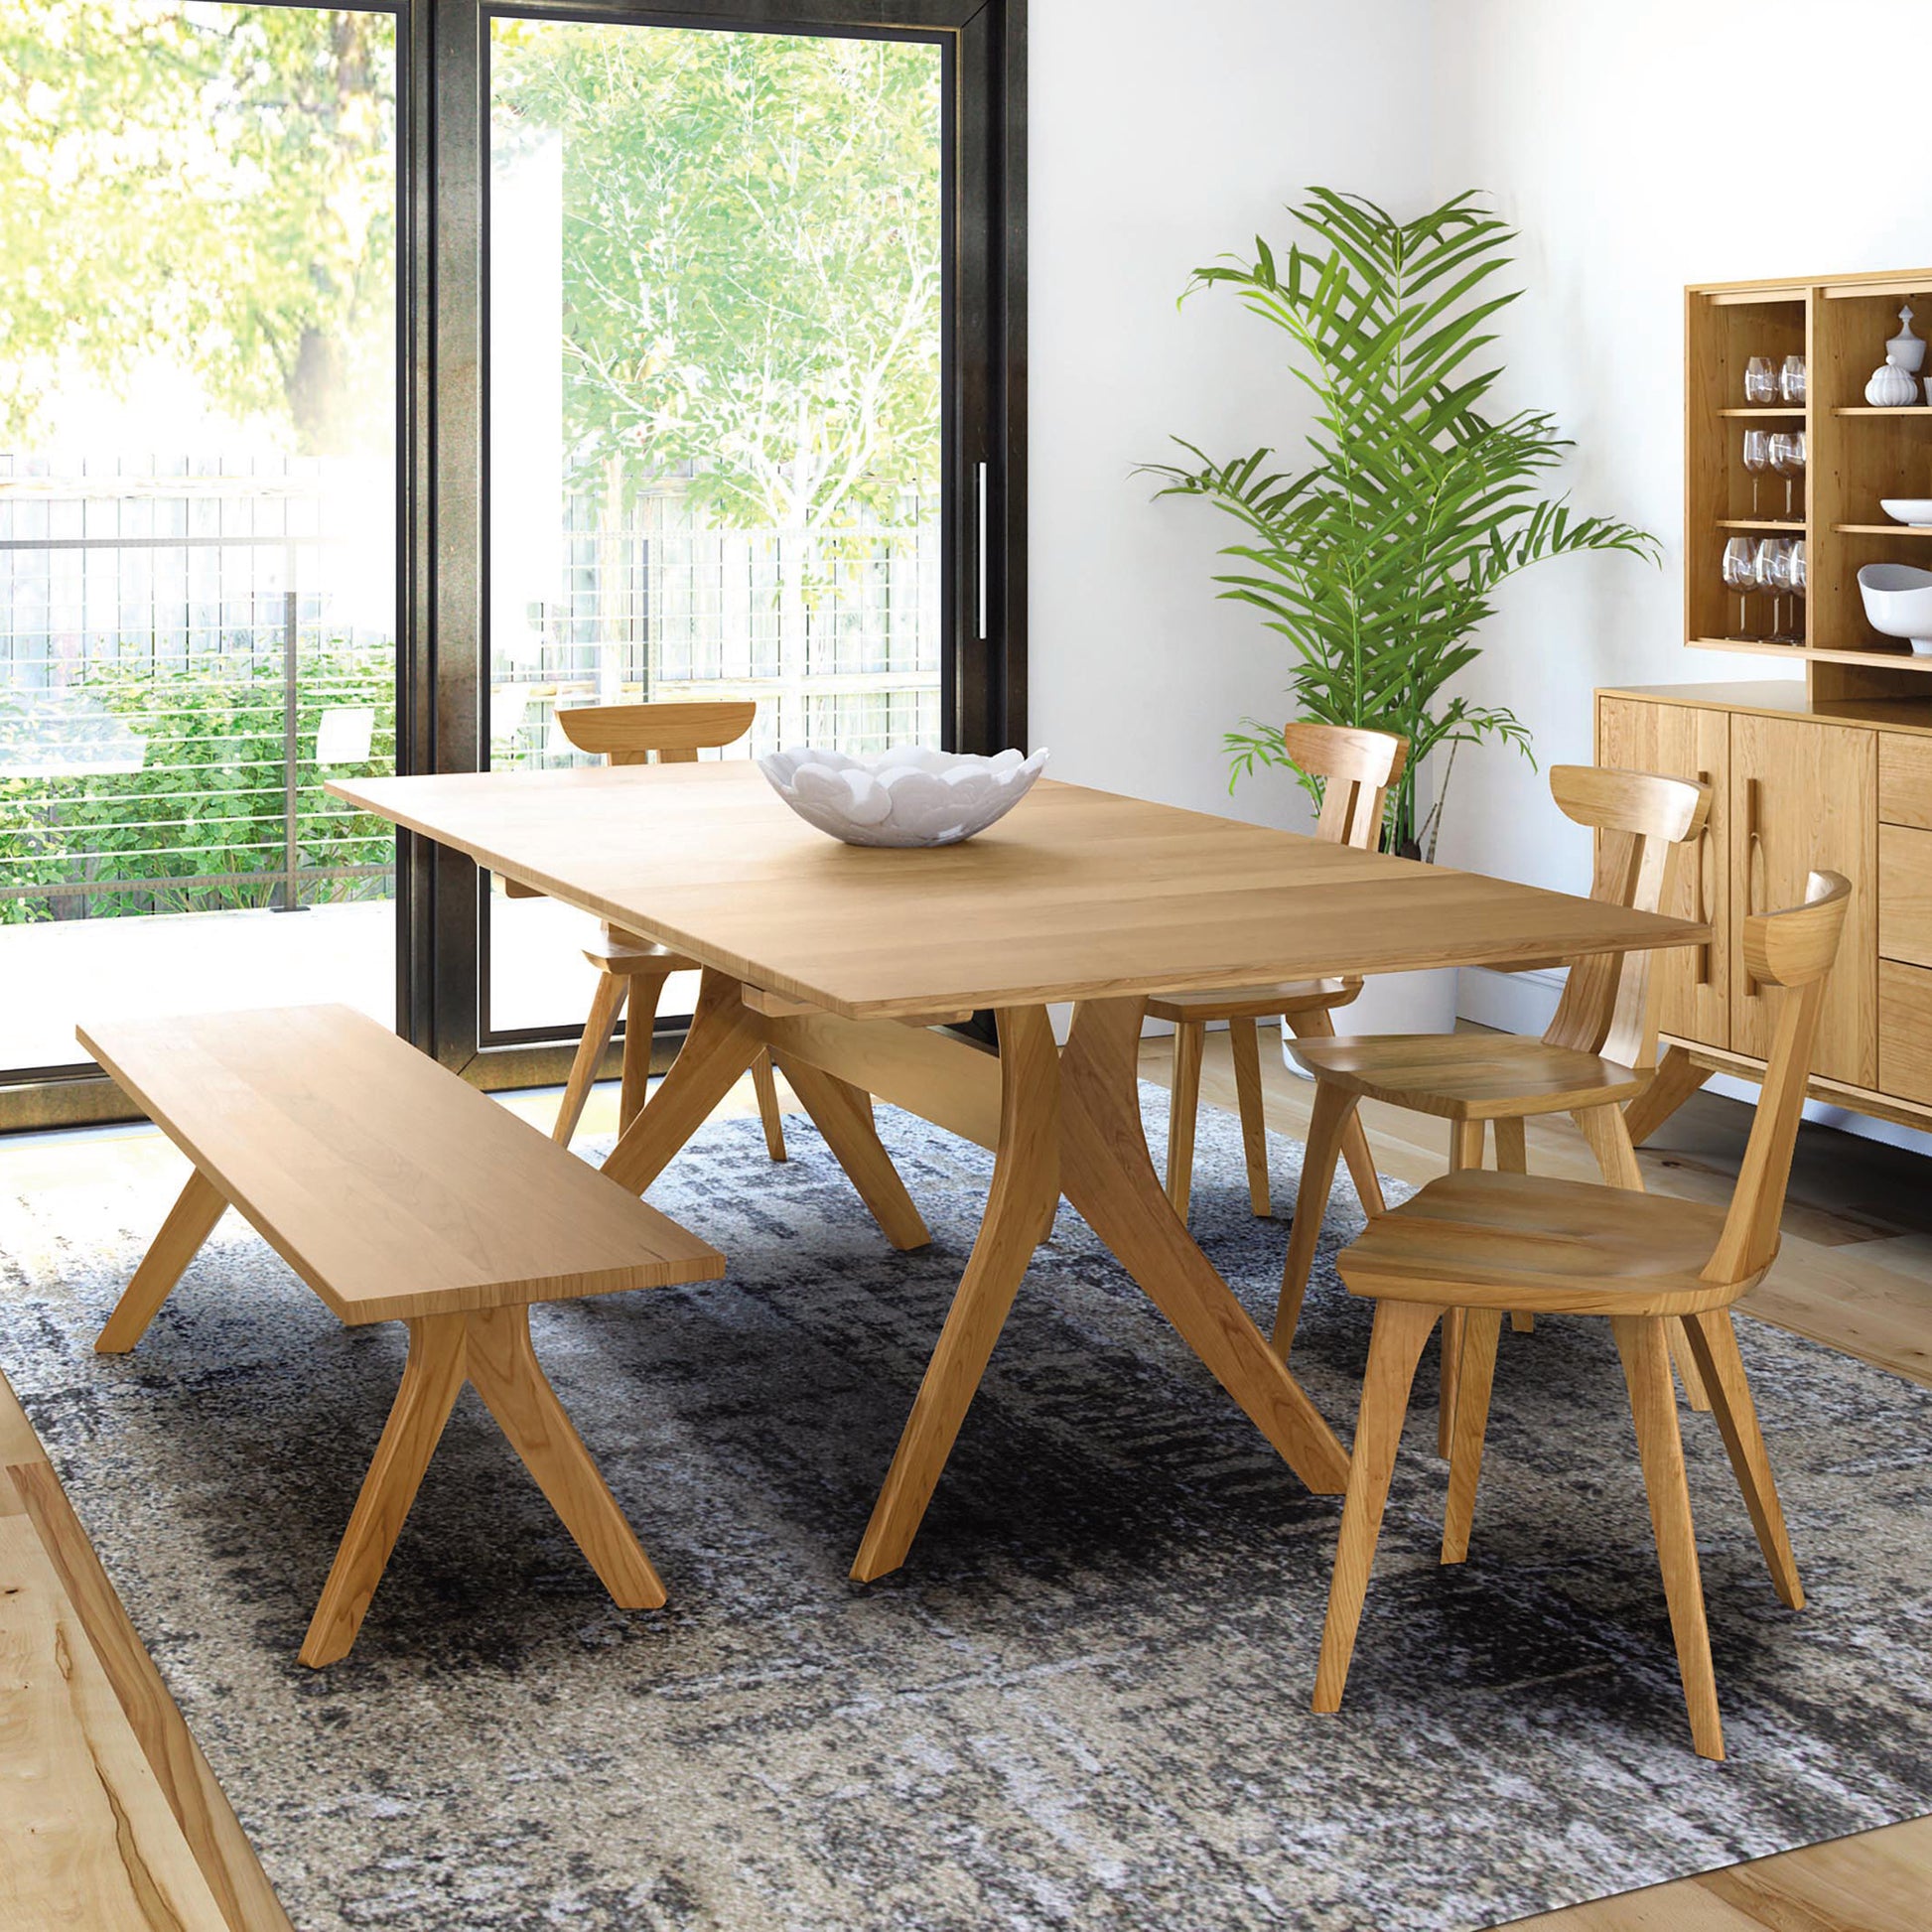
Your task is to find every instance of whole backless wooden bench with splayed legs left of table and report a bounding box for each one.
[77,1007,725,1665]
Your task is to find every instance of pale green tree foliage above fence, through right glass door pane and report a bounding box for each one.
[492,21,941,531]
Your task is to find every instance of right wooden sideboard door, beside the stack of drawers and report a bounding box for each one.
[1731,711,1878,1088]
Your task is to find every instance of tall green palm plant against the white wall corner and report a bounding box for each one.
[1144,188,1660,856]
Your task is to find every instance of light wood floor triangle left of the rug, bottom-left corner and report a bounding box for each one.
[0,1376,292,1932]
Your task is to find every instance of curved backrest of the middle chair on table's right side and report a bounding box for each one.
[1544,765,1710,1066]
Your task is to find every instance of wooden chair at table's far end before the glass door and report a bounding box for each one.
[551,699,784,1162]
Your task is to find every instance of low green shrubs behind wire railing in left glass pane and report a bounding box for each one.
[0,647,396,923]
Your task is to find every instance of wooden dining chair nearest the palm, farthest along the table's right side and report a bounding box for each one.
[1148,723,1409,1221]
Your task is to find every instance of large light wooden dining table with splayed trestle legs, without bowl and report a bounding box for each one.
[329,761,1710,1581]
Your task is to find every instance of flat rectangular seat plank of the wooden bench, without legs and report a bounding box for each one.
[77,1007,725,1325]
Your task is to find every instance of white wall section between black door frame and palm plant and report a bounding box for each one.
[1028,0,1442,823]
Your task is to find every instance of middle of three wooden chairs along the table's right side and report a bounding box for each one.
[1275,765,1710,1454]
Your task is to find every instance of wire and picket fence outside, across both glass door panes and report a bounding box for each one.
[0,454,939,923]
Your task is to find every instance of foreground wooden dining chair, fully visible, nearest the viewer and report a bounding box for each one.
[1313,872,1851,1758]
